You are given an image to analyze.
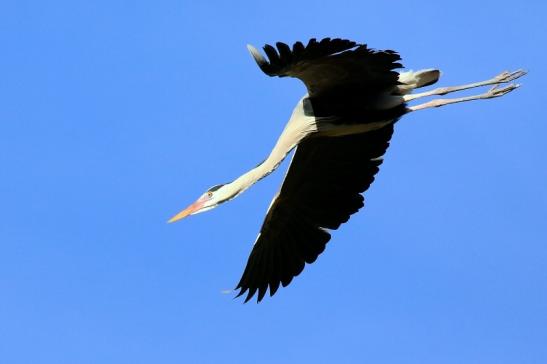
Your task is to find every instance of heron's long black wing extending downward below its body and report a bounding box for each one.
[236,124,393,302]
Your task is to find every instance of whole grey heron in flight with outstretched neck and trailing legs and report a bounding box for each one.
[169,38,526,302]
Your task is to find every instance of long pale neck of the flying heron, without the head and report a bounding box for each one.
[227,99,317,197]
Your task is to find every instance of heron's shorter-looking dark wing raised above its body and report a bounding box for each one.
[248,38,402,97]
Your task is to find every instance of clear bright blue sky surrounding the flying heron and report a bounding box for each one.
[0,0,547,364]
